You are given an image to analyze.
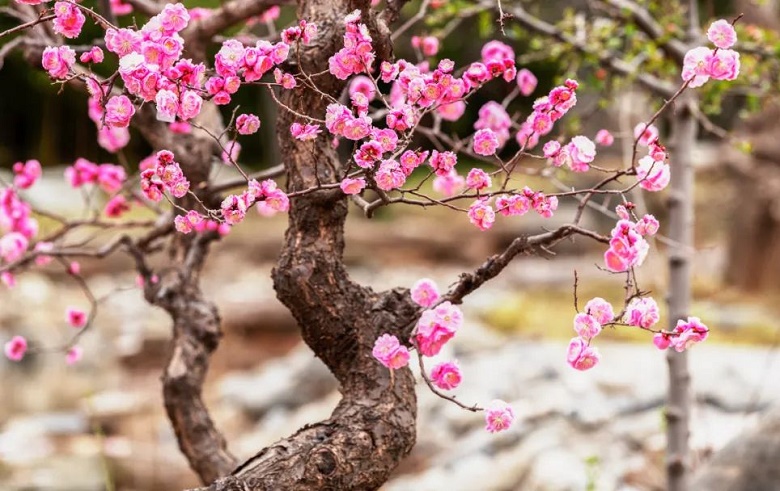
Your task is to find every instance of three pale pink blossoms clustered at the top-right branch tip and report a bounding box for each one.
[682,19,740,88]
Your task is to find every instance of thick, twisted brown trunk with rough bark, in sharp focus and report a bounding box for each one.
[181,0,426,490]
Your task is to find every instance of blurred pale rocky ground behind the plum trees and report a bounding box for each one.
[0,171,780,491]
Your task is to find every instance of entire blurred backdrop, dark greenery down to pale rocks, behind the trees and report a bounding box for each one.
[0,0,780,491]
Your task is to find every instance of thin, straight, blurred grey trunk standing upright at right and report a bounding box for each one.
[665,0,699,491]
